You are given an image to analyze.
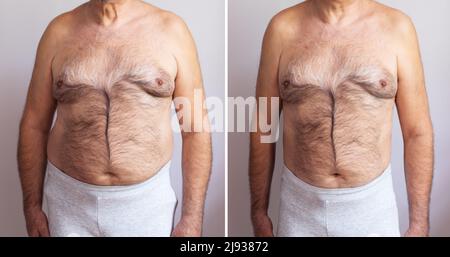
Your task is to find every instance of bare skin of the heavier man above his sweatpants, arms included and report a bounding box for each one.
[18,0,211,236]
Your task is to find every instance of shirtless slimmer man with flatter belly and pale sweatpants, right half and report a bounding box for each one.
[250,0,433,236]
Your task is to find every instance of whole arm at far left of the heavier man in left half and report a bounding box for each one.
[17,19,60,236]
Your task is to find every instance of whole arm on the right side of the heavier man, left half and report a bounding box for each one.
[172,18,212,236]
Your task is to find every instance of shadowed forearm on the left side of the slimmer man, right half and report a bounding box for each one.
[249,133,275,217]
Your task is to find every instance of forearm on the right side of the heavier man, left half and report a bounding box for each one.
[182,132,212,226]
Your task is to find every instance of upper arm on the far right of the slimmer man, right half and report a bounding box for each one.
[396,16,432,138]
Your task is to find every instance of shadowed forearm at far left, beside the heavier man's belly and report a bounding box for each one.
[17,126,48,211]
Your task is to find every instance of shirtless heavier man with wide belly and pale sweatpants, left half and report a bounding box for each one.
[18,0,211,236]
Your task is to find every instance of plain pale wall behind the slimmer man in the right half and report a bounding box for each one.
[228,0,450,236]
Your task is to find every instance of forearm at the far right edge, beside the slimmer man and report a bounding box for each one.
[405,133,433,232]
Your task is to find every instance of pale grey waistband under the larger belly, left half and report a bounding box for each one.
[46,161,171,192]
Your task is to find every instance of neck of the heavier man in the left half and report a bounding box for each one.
[89,0,134,26]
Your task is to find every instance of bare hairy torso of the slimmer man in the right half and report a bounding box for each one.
[279,2,397,187]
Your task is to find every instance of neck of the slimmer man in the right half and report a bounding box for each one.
[311,0,367,24]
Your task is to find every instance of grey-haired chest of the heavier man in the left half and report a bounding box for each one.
[52,41,176,103]
